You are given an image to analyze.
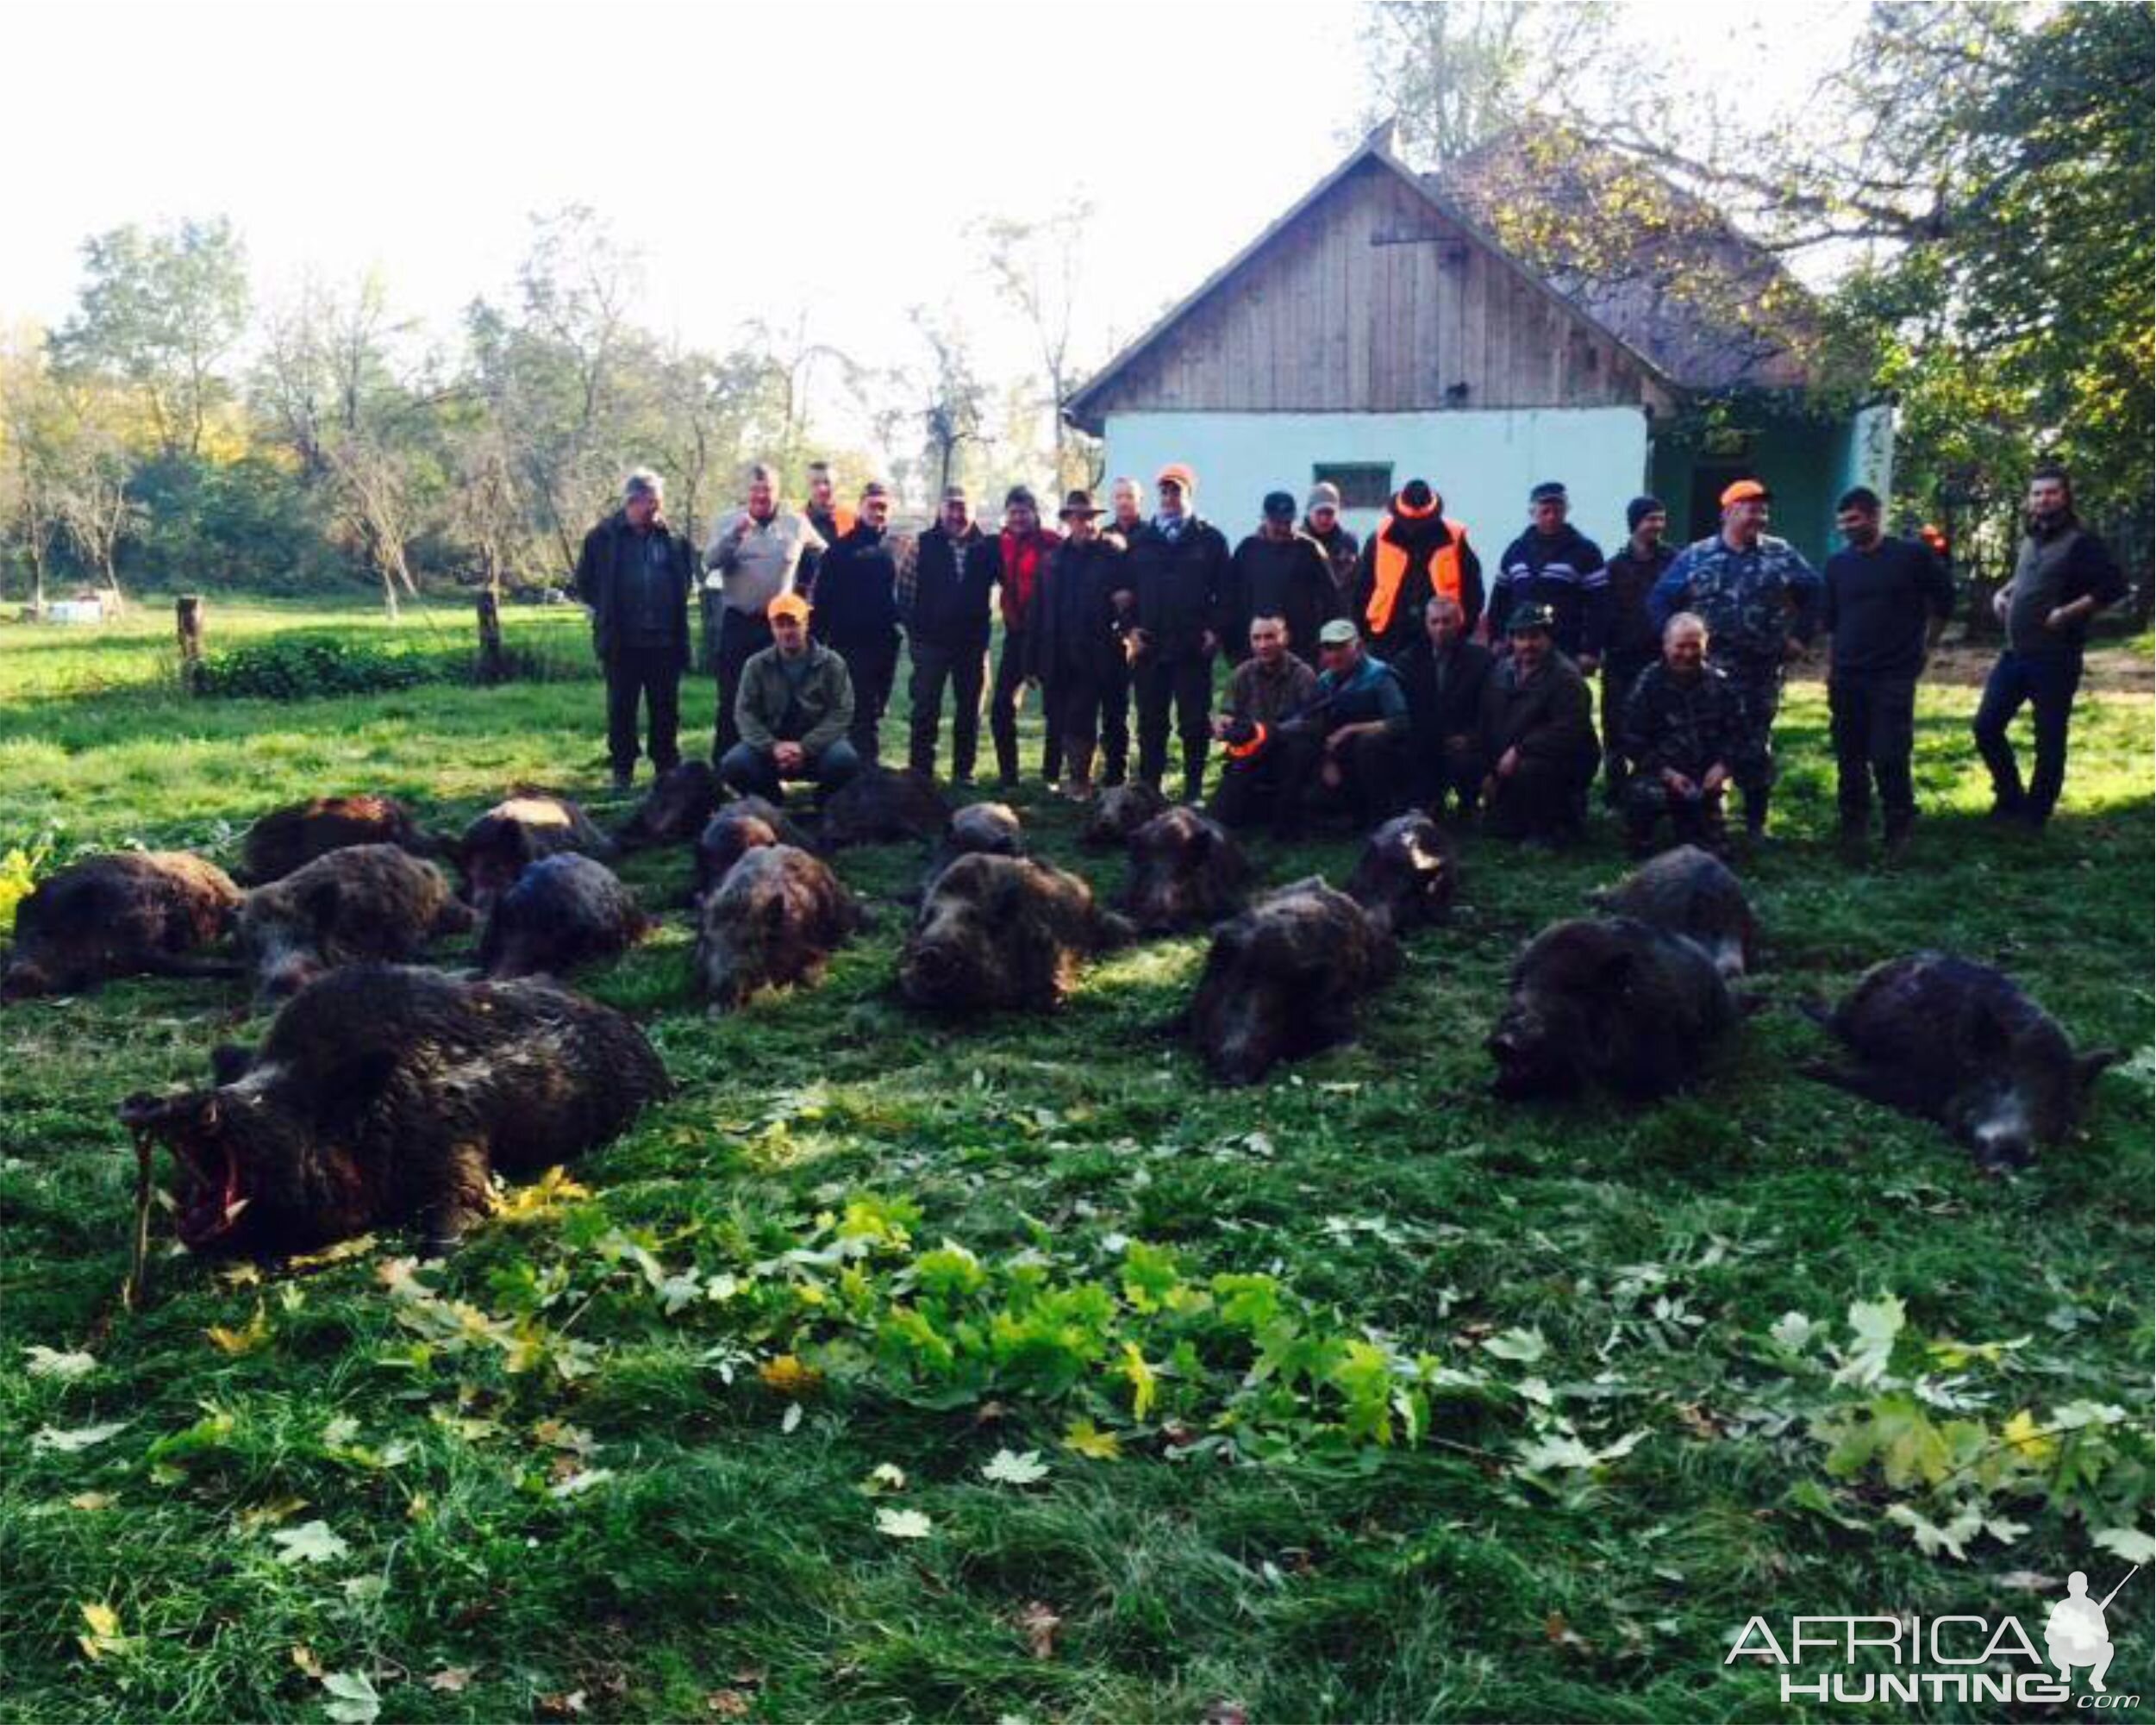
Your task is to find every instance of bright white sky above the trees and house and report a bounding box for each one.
[0,0,1847,450]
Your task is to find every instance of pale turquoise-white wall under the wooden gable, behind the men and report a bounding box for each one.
[1102,408,1647,559]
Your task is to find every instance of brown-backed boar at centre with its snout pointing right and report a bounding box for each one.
[899,856,1132,1011]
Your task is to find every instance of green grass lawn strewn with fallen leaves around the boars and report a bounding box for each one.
[0,606,2156,1725]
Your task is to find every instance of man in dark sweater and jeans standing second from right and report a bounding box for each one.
[1820,485,1953,860]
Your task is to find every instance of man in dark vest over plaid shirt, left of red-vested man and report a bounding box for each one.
[899,485,994,784]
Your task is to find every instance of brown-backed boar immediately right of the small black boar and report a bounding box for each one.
[697,845,860,1014]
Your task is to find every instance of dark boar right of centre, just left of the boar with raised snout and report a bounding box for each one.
[1184,878,1399,1084]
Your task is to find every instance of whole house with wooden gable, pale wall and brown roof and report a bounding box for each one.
[1065,129,1890,559]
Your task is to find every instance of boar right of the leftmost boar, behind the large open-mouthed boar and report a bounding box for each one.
[240,845,472,1001]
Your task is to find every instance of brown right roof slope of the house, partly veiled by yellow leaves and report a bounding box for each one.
[1425,125,1820,392]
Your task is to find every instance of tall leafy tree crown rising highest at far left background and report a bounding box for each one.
[54,216,248,457]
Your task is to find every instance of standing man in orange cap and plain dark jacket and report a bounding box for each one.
[1130,461,1229,804]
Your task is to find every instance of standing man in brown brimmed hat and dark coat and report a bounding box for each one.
[1033,491,1130,797]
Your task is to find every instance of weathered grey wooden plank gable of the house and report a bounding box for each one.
[1089,162,1660,414]
